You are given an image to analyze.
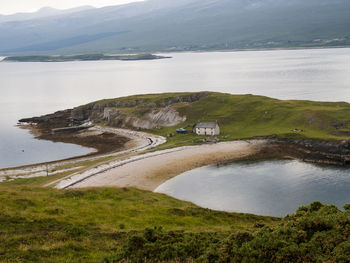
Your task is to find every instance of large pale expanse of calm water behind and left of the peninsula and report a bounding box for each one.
[0,48,350,168]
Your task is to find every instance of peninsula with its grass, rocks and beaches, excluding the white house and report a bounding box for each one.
[12,92,350,190]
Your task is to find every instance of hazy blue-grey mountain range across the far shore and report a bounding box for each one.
[0,0,350,55]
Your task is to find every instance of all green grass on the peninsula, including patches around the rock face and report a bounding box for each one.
[97,93,350,144]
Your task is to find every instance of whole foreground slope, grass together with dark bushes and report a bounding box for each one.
[0,186,350,263]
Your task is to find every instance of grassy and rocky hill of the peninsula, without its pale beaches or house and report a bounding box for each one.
[19,92,350,167]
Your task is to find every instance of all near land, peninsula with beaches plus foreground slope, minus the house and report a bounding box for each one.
[0,92,350,262]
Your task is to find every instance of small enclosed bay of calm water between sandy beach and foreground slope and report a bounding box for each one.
[156,160,350,216]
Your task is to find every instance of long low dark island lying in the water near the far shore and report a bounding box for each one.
[3,54,169,62]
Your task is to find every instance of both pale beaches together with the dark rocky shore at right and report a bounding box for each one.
[0,122,350,191]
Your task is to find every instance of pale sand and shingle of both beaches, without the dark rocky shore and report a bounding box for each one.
[0,126,268,191]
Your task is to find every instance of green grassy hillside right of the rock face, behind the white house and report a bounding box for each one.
[172,93,350,139]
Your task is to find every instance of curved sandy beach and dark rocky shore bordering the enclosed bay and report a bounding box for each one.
[55,139,349,191]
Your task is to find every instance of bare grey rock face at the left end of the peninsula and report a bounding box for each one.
[20,92,209,129]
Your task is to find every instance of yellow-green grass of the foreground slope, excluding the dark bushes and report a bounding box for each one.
[0,186,279,262]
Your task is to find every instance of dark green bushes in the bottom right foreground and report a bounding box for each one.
[105,202,350,263]
